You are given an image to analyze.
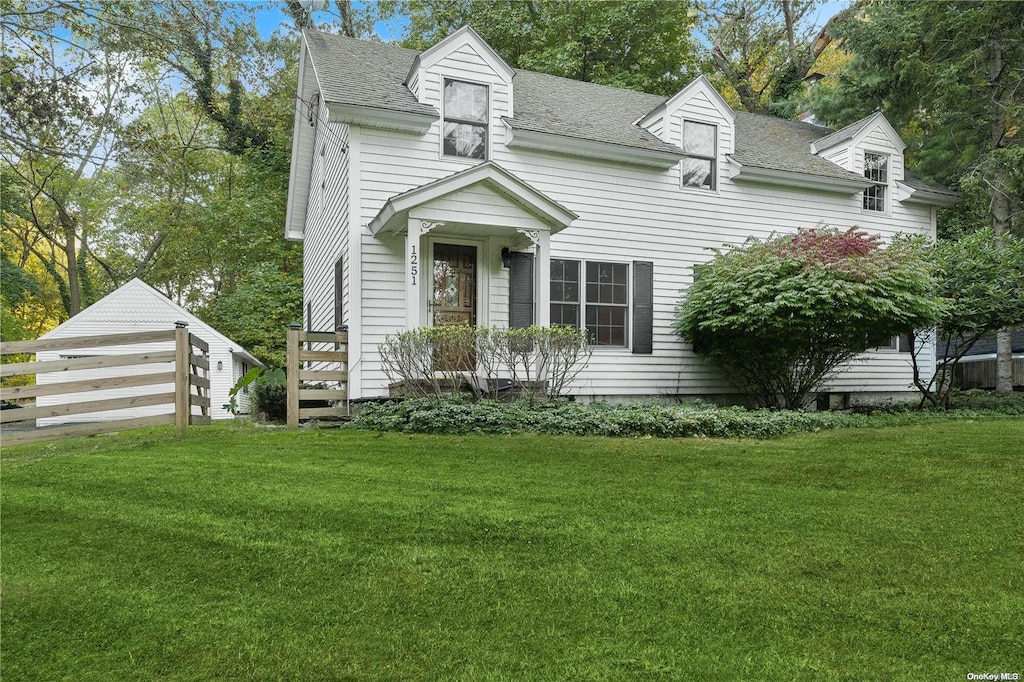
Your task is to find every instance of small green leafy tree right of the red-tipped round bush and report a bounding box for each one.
[912,229,1024,407]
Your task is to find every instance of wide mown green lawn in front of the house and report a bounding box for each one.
[0,419,1024,682]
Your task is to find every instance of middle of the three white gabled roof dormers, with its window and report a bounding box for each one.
[637,76,735,191]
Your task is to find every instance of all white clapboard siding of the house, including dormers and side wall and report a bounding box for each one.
[304,67,934,397]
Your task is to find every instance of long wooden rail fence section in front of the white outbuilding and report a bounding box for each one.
[0,326,210,445]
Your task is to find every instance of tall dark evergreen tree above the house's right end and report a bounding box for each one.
[812,1,1024,392]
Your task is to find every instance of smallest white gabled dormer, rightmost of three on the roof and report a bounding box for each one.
[811,112,906,214]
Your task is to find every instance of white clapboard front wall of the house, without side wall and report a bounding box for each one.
[342,115,931,396]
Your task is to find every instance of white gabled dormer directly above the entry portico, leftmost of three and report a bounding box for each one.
[406,27,514,161]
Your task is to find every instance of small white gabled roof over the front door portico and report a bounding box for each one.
[369,161,579,237]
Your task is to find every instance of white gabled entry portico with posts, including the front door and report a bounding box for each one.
[369,162,578,329]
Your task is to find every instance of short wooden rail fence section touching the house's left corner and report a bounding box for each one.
[287,327,349,429]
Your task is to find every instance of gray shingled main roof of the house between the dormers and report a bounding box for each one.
[296,31,929,186]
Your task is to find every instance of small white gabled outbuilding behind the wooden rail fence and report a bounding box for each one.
[36,279,263,419]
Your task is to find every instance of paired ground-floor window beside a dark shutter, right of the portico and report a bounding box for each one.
[551,258,630,347]
